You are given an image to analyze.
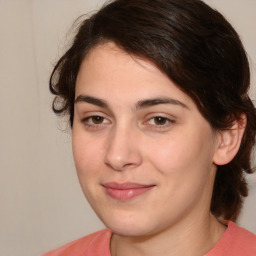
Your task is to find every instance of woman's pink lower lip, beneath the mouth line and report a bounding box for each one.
[105,186,154,201]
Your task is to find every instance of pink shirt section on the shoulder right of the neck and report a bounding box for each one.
[205,221,256,256]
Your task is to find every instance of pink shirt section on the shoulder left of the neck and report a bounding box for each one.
[42,229,111,256]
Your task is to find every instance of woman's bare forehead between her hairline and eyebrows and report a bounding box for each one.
[76,43,194,105]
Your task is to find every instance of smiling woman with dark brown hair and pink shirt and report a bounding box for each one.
[41,0,256,256]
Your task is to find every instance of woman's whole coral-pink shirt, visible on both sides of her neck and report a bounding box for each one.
[42,221,256,256]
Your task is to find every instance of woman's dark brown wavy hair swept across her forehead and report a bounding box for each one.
[50,0,256,220]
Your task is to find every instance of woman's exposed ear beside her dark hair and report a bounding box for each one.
[213,114,247,165]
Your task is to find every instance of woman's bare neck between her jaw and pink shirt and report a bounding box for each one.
[111,214,225,256]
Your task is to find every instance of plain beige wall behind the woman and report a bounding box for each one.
[0,0,256,256]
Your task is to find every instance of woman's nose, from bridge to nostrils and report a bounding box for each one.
[105,127,142,171]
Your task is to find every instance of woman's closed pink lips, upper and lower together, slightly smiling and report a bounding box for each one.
[103,182,155,201]
